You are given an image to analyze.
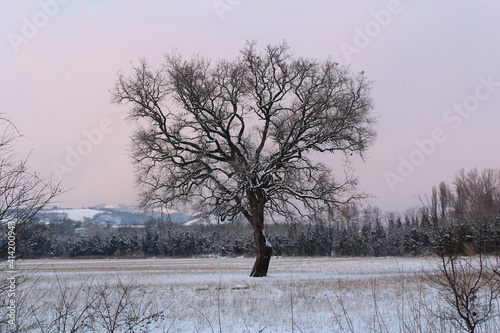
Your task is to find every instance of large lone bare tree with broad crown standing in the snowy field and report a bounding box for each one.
[112,43,375,277]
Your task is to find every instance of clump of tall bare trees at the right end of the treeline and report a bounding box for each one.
[422,169,500,255]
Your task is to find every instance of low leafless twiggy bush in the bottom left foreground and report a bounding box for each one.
[7,274,168,333]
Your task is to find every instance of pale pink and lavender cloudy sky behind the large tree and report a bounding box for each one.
[0,0,500,210]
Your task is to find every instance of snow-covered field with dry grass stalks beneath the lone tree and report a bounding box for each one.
[8,258,500,333]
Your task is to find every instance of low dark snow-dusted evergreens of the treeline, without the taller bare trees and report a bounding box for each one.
[16,209,500,258]
